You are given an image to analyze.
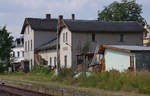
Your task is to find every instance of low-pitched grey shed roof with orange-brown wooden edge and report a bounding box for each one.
[99,45,150,53]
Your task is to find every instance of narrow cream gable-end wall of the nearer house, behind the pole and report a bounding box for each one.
[59,28,72,68]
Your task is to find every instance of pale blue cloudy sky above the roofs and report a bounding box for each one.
[0,0,150,37]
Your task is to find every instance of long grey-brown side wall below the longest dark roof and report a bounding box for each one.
[72,32,143,67]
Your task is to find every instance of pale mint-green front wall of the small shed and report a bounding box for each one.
[104,49,136,72]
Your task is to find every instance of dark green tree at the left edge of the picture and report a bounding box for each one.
[0,26,13,63]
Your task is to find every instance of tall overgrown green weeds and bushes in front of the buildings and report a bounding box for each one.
[4,66,150,94]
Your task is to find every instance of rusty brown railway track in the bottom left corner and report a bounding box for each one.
[0,83,54,96]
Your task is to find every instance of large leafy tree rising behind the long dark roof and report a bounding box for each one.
[98,0,144,25]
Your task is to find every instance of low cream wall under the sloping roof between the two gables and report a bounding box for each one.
[38,50,57,66]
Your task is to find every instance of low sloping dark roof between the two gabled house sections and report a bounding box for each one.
[35,37,57,52]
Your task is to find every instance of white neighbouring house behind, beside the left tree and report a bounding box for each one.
[11,36,24,64]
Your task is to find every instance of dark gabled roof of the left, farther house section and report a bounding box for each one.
[21,18,58,34]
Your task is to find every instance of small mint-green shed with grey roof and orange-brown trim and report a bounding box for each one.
[99,45,150,72]
